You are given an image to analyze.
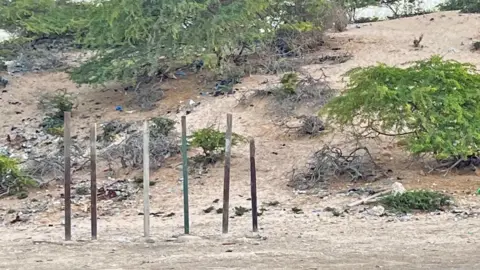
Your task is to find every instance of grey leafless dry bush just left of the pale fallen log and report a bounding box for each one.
[288,146,385,190]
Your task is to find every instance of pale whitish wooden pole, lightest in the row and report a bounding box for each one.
[143,121,150,237]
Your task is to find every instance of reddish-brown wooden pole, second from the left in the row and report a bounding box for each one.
[90,124,97,240]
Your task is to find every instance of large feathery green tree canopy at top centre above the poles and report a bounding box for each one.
[71,0,328,83]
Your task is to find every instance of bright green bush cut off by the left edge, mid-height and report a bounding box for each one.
[0,155,36,195]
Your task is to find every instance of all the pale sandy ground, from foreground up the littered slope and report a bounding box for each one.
[0,12,480,269]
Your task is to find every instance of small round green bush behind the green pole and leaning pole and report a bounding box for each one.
[190,127,245,157]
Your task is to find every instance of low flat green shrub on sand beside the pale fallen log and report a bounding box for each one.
[379,190,452,213]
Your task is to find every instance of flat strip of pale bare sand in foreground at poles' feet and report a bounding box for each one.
[0,212,480,270]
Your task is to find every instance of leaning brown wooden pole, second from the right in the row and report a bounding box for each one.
[222,113,232,233]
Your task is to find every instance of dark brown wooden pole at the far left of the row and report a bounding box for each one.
[63,112,72,241]
